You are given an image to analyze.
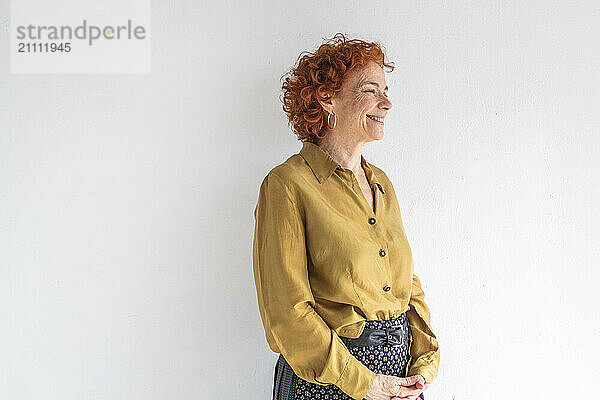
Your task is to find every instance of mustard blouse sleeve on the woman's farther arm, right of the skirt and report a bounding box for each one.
[406,274,440,382]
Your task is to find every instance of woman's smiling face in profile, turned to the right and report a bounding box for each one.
[324,62,392,142]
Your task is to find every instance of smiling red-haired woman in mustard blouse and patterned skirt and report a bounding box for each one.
[253,34,440,400]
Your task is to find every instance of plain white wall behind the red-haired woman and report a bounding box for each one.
[0,0,600,400]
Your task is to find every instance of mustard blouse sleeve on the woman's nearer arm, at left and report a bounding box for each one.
[253,172,375,400]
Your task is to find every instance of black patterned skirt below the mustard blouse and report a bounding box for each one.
[273,313,425,400]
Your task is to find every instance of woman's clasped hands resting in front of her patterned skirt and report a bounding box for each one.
[365,374,430,400]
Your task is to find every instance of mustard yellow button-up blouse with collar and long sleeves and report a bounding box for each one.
[253,142,440,400]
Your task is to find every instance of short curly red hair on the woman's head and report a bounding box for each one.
[280,33,394,144]
